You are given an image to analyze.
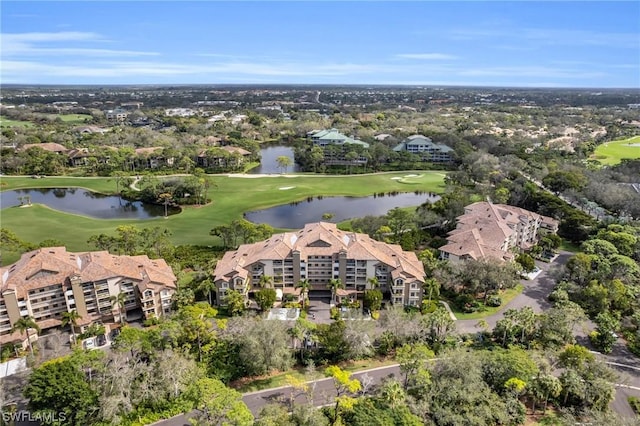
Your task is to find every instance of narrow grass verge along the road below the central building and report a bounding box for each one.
[234,358,397,393]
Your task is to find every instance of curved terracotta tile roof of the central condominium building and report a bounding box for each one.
[214,222,424,280]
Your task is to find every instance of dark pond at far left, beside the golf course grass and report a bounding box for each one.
[0,188,180,219]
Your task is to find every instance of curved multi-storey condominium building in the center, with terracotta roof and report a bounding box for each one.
[214,222,425,306]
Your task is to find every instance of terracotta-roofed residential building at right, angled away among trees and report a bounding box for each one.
[440,201,558,261]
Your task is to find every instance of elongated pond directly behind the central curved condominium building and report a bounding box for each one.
[244,192,440,229]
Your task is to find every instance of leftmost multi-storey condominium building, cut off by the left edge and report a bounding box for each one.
[0,247,176,343]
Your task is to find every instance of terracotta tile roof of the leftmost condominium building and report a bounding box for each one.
[0,247,176,299]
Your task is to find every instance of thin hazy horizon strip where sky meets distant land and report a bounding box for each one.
[2,83,640,91]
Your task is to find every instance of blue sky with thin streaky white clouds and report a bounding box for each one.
[0,0,640,88]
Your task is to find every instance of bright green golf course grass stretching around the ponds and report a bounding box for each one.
[0,171,444,262]
